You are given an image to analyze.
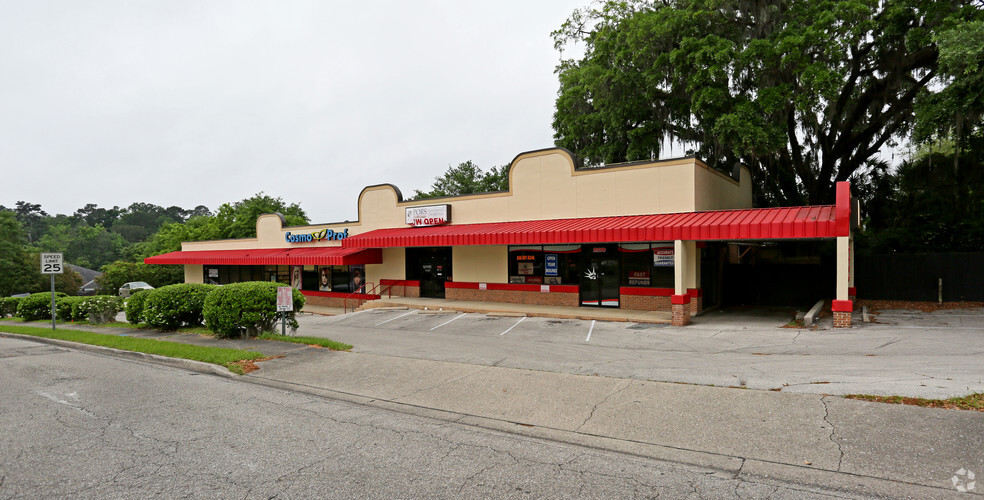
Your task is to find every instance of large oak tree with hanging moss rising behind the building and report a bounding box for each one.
[553,0,984,205]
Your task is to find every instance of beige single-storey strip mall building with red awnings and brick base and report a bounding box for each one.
[145,148,856,326]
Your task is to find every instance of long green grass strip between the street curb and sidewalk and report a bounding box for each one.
[0,325,264,375]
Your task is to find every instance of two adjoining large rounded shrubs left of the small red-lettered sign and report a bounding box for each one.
[126,281,304,337]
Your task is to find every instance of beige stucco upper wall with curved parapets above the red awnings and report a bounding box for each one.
[175,149,752,252]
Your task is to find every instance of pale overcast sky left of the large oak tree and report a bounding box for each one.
[0,0,589,222]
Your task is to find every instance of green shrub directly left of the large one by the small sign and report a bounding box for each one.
[141,283,216,331]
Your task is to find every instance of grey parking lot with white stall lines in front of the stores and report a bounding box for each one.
[298,309,984,397]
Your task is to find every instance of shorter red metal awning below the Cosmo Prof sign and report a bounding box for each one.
[144,247,383,266]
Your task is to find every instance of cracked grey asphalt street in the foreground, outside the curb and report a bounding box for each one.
[0,338,850,499]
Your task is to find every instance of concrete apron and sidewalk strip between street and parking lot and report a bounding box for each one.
[3,320,984,498]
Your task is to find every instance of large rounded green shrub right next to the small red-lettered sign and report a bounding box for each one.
[204,281,304,337]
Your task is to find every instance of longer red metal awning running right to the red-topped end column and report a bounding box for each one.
[342,205,846,248]
